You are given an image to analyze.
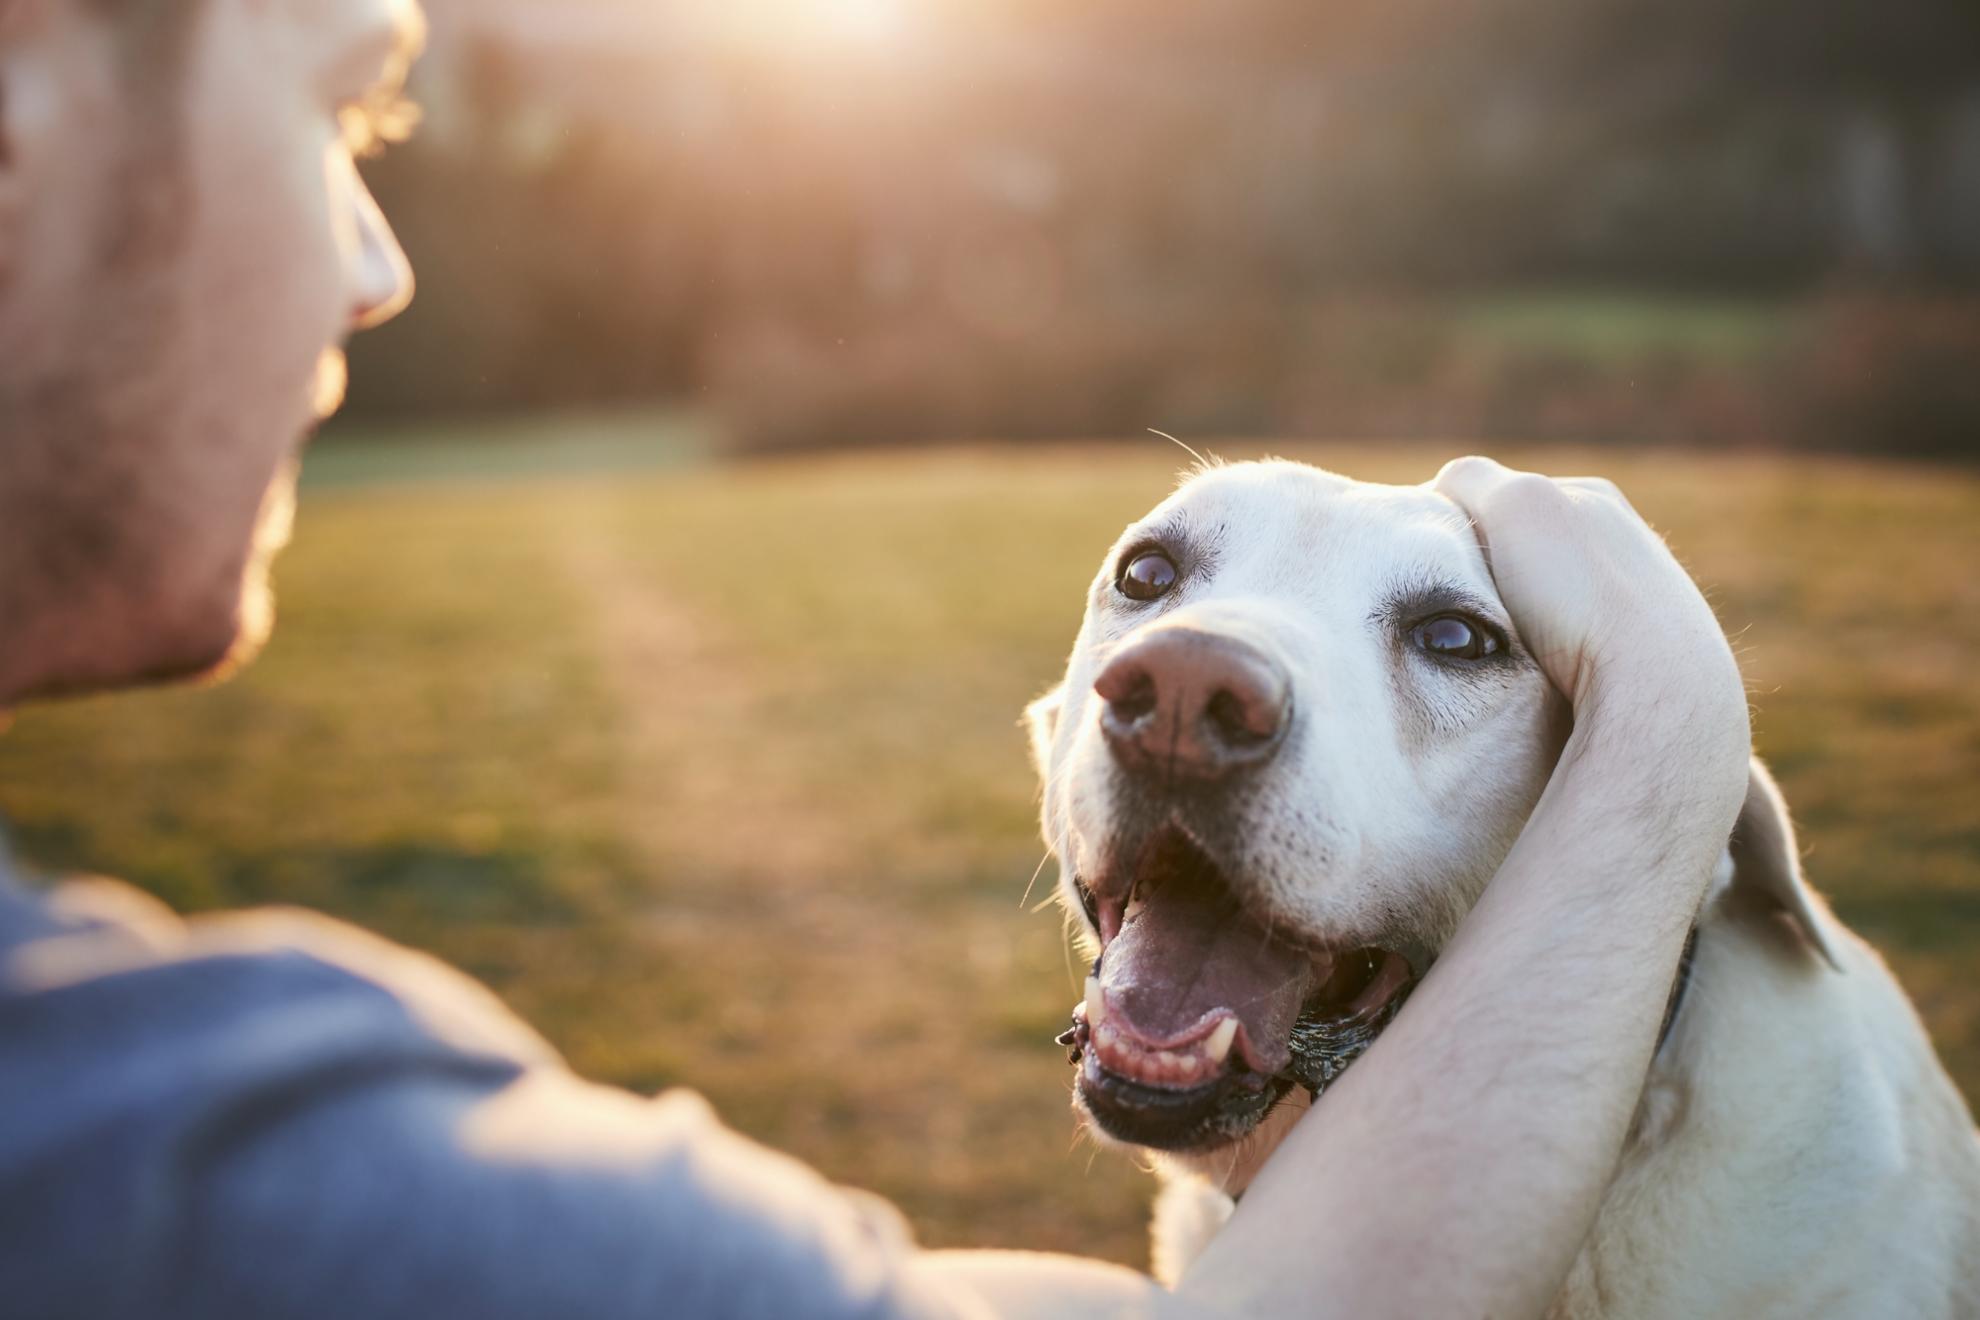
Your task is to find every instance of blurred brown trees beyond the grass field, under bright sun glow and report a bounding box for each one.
[332,0,1980,459]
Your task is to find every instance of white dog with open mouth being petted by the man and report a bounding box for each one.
[1028,461,1980,1318]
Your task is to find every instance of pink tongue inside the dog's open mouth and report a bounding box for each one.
[1099,867,1313,1073]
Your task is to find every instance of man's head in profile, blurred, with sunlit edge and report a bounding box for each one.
[0,0,420,708]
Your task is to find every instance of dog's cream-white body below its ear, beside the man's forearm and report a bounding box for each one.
[1556,889,1980,1318]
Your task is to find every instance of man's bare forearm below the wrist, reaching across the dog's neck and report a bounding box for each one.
[1182,680,1744,1316]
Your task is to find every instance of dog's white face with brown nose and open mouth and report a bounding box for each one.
[1032,461,1568,1152]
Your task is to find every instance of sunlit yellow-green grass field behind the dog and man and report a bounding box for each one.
[0,424,1980,1261]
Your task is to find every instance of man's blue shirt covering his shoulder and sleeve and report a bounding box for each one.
[0,853,948,1320]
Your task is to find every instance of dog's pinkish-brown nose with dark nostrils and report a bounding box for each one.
[1093,627,1293,780]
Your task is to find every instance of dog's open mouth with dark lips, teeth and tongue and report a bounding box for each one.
[1059,827,1416,1150]
